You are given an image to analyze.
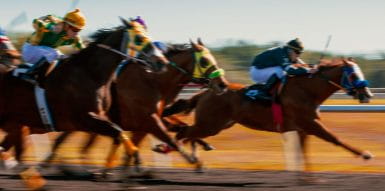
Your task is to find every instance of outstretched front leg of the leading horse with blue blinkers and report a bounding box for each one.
[304,119,373,160]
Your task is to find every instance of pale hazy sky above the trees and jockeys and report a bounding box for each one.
[0,0,385,54]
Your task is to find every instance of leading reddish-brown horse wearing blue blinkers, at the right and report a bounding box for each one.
[164,59,372,170]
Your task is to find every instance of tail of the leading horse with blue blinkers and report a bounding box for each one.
[162,91,205,117]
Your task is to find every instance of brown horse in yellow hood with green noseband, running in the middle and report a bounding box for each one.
[46,39,227,173]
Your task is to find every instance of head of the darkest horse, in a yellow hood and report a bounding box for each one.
[121,18,169,70]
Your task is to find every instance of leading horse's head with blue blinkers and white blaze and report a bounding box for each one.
[341,59,373,103]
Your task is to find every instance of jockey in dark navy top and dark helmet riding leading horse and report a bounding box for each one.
[246,38,317,100]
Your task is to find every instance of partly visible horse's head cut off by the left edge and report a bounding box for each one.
[0,33,21,66]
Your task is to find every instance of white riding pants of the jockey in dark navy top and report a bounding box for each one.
[249,66,286,84]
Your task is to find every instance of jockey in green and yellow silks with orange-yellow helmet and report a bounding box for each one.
[22,9,86,81]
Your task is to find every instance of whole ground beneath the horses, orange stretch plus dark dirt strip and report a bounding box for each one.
[0,113,385,191]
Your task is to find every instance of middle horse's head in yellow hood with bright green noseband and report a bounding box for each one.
[190,39,228,94]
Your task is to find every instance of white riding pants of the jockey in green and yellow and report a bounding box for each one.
[22,43,63,64]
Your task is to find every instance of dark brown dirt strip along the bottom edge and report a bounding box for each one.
[0,166,385,191]
